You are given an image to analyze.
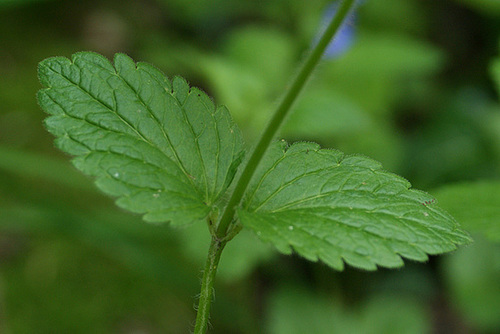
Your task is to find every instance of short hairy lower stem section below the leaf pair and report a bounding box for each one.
[194,237,226,334]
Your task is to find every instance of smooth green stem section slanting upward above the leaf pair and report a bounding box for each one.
[216,0,355,239]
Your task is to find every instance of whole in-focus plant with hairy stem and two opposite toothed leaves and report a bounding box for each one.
[38,0,470,333]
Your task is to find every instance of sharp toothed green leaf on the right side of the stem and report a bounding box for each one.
[238,142,470,270]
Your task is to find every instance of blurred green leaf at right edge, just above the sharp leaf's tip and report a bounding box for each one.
[434,180,500,242]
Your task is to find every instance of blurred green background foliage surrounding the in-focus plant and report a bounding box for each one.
[0,0,500,334]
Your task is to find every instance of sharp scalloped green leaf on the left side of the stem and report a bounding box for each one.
[38,52,243,224]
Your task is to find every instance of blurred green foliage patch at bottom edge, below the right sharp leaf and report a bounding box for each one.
[267,286,430,334]
